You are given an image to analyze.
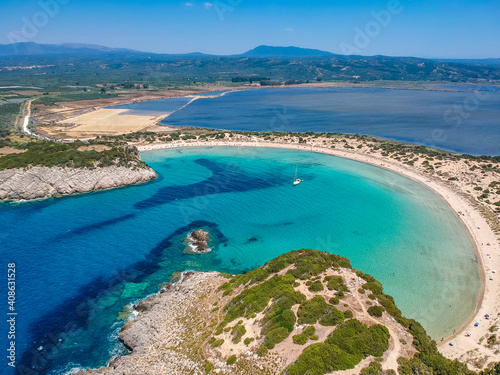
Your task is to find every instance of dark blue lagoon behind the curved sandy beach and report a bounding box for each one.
[109,84,500,155]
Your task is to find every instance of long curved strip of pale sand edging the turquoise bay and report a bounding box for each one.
[137,141,500,366]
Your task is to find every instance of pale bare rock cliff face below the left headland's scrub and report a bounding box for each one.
[0,166,156,200]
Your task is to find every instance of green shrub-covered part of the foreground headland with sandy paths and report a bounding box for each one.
[201,250,473,375]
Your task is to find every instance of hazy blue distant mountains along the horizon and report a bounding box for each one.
[0,42,500,65]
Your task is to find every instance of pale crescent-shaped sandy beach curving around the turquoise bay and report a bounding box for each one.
[137,139,500,369]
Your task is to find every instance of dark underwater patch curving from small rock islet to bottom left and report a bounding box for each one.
[16,222,227,375]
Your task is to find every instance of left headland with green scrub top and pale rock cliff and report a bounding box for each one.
[0,142,156,201]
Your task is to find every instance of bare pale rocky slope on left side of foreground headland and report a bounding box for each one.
[77,272,227,375]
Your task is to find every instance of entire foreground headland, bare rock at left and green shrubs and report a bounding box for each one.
[73,250,474,375]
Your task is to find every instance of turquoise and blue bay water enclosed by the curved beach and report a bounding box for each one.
[0,147,480,374]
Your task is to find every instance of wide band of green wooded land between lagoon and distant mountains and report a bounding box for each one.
[0,51,500,90]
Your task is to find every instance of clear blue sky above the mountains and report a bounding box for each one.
[0,0,500,58]
